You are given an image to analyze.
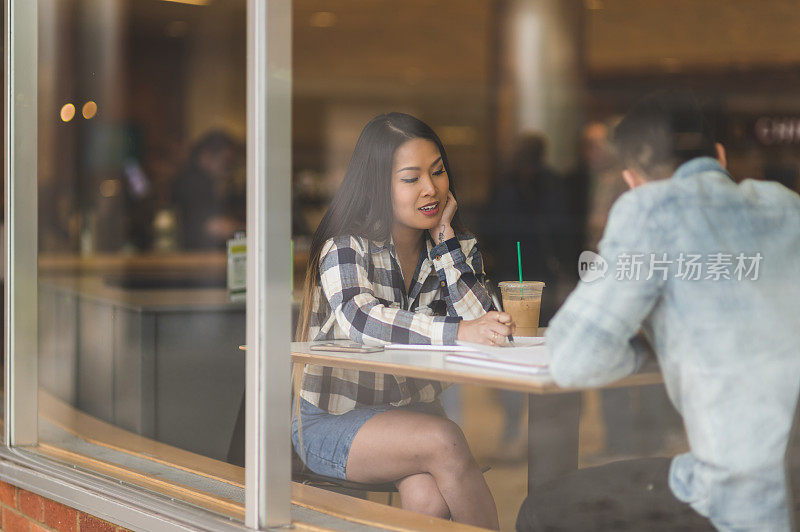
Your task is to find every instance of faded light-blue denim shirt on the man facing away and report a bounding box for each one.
[547,157,800,531]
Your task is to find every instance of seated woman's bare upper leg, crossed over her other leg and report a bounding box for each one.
[347,410,498,529]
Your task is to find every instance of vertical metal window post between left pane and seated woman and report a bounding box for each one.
[245,0,292,529]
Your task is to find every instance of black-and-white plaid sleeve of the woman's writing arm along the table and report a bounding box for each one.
[320,236,461,344]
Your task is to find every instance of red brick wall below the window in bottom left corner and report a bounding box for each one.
[0,482,127,532]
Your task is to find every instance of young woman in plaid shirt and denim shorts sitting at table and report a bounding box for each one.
[292,113,514,529]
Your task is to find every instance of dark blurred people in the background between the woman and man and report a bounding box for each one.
[474,122,625,325]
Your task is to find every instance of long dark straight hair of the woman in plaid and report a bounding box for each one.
[297,113,466,341]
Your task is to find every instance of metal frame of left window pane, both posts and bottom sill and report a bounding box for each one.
[0,0,292,530]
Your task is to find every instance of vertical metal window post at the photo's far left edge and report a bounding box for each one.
[3,0,38,445]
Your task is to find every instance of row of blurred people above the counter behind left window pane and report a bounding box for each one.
[39,127,246,253]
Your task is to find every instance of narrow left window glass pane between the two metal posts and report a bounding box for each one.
[39,0,246,517]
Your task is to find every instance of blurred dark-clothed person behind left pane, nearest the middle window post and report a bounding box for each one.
[172,130,245,249]
